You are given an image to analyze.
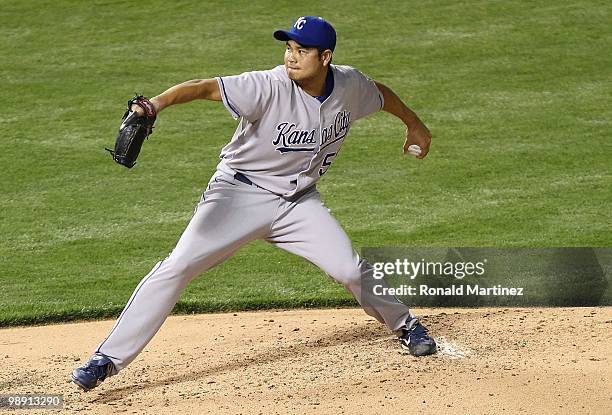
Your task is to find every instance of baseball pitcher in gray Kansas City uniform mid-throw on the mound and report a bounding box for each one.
[72,16,436,391]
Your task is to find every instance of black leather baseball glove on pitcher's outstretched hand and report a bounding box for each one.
[106,95,157,169]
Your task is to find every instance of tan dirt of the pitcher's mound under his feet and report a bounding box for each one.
[0,307,612,415]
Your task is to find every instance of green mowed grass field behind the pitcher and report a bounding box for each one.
[0,0,612,325]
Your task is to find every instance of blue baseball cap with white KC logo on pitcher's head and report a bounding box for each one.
[274,16,336,51]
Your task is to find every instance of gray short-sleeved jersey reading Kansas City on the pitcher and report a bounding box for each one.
[217,65,383,197]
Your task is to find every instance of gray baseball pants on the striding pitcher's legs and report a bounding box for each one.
[96,171,412,374]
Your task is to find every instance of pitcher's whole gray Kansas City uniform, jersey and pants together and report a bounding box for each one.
[92,65,412,374]
